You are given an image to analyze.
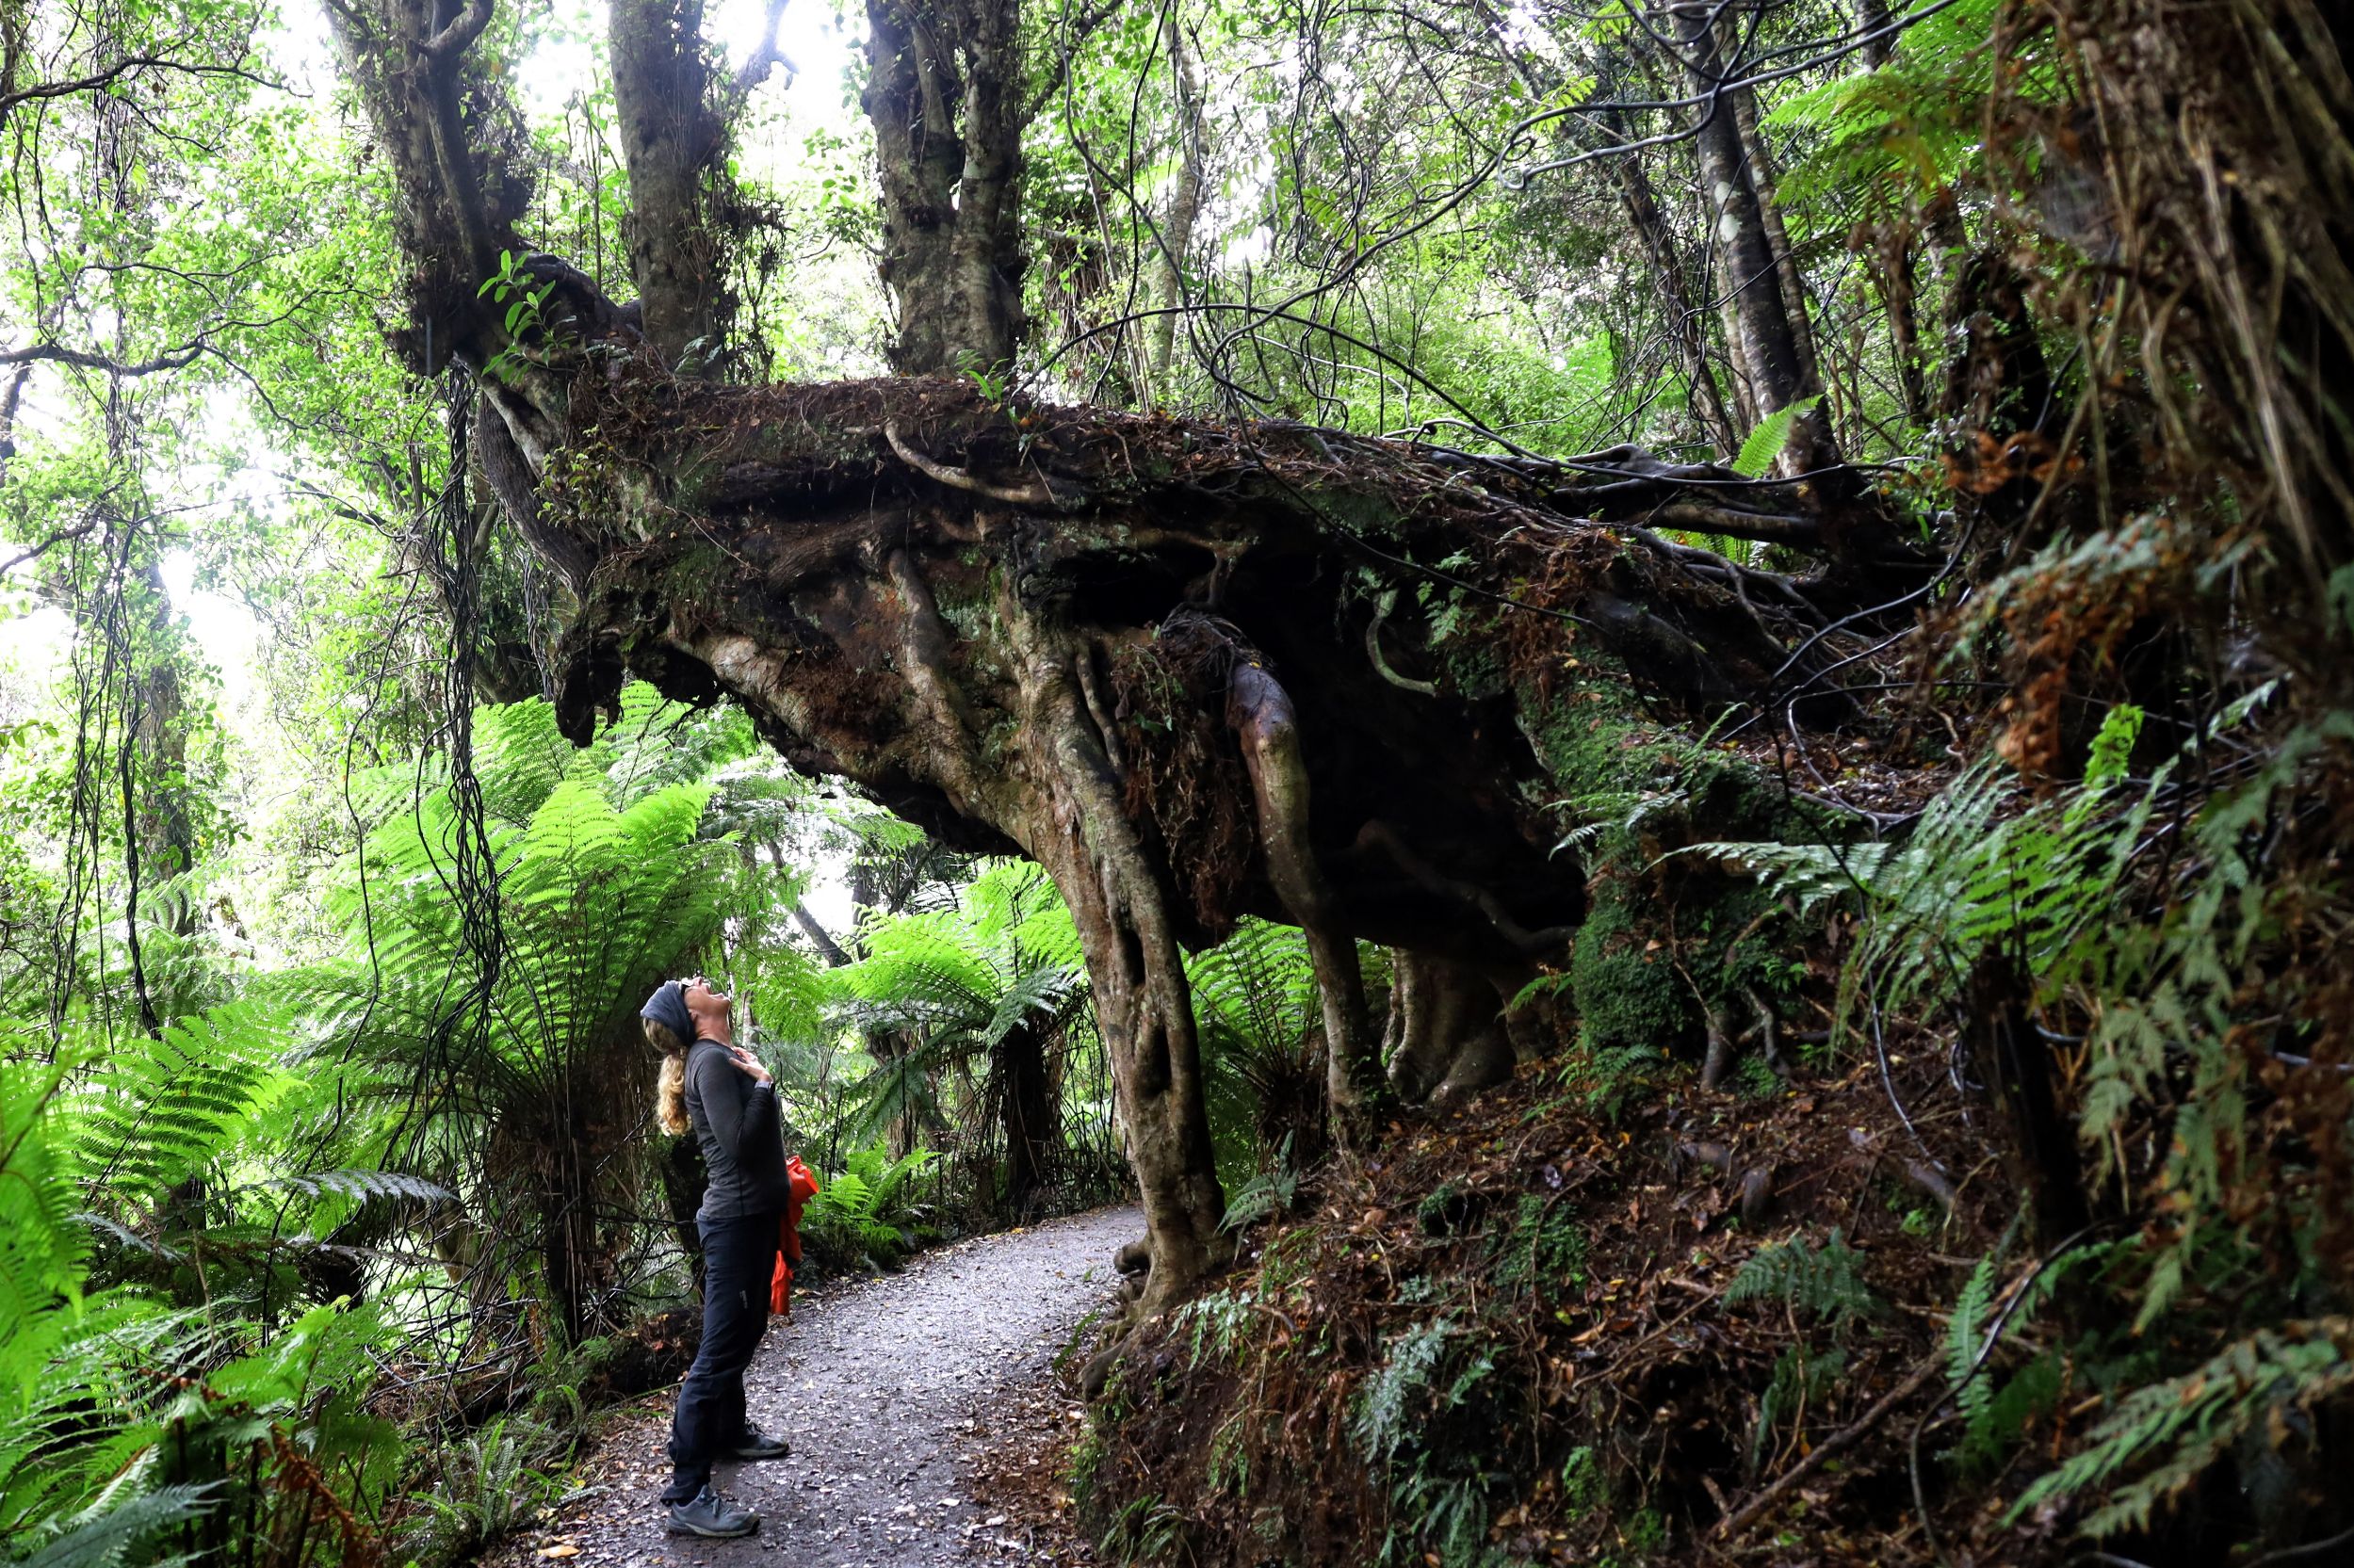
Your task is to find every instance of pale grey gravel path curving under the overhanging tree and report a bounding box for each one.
[506,1208,1145,1568]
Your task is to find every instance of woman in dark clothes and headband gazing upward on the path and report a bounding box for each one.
[638,975,791,1538]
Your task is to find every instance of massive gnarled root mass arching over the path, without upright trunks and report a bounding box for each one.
[501,367,1919,1312]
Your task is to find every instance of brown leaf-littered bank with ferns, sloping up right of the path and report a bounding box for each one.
[1059,690,2354,1568]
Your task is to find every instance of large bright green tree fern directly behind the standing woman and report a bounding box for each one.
[294,700,739,1333]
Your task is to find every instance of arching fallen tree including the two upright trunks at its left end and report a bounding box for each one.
[336,0,1933,1312]
